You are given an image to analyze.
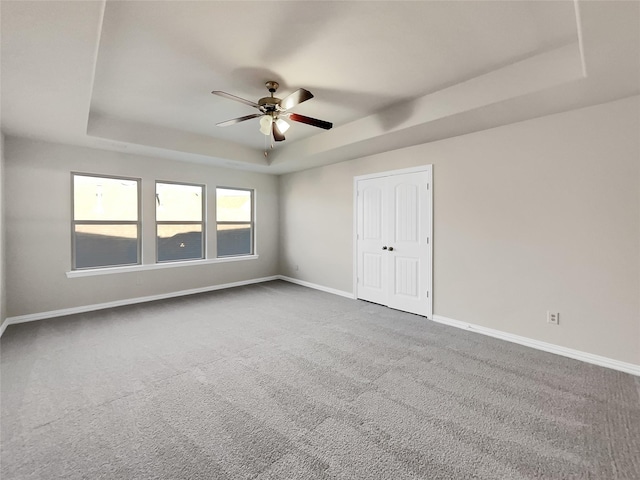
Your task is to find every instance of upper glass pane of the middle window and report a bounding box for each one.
[156,183,203,222]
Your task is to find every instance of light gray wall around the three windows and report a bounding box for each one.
[5,136,278,317]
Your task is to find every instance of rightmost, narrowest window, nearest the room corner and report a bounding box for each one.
[216,188,253,257]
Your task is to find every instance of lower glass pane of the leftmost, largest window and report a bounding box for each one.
[74,225,138,268]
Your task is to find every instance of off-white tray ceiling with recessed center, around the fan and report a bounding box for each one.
[0,0,640,174]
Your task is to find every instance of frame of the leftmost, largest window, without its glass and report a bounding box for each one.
[70,171,142,272]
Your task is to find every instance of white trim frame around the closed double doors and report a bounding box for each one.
[352,164,434,320]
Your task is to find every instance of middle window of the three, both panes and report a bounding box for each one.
[156,182,205,262]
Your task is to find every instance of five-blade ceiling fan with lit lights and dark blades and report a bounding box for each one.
[211,81,333,142]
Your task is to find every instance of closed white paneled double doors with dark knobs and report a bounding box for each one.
[355,165,433,318]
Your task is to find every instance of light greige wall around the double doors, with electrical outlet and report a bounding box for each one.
[280,96,640,365]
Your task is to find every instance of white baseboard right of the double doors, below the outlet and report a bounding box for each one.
[433,315,640,376]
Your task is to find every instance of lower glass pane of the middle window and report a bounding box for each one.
[158,225,203,262]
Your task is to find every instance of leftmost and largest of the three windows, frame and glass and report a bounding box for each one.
[71,173,141,270]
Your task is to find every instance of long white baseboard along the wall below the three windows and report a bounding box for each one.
[0,275,279,336]
